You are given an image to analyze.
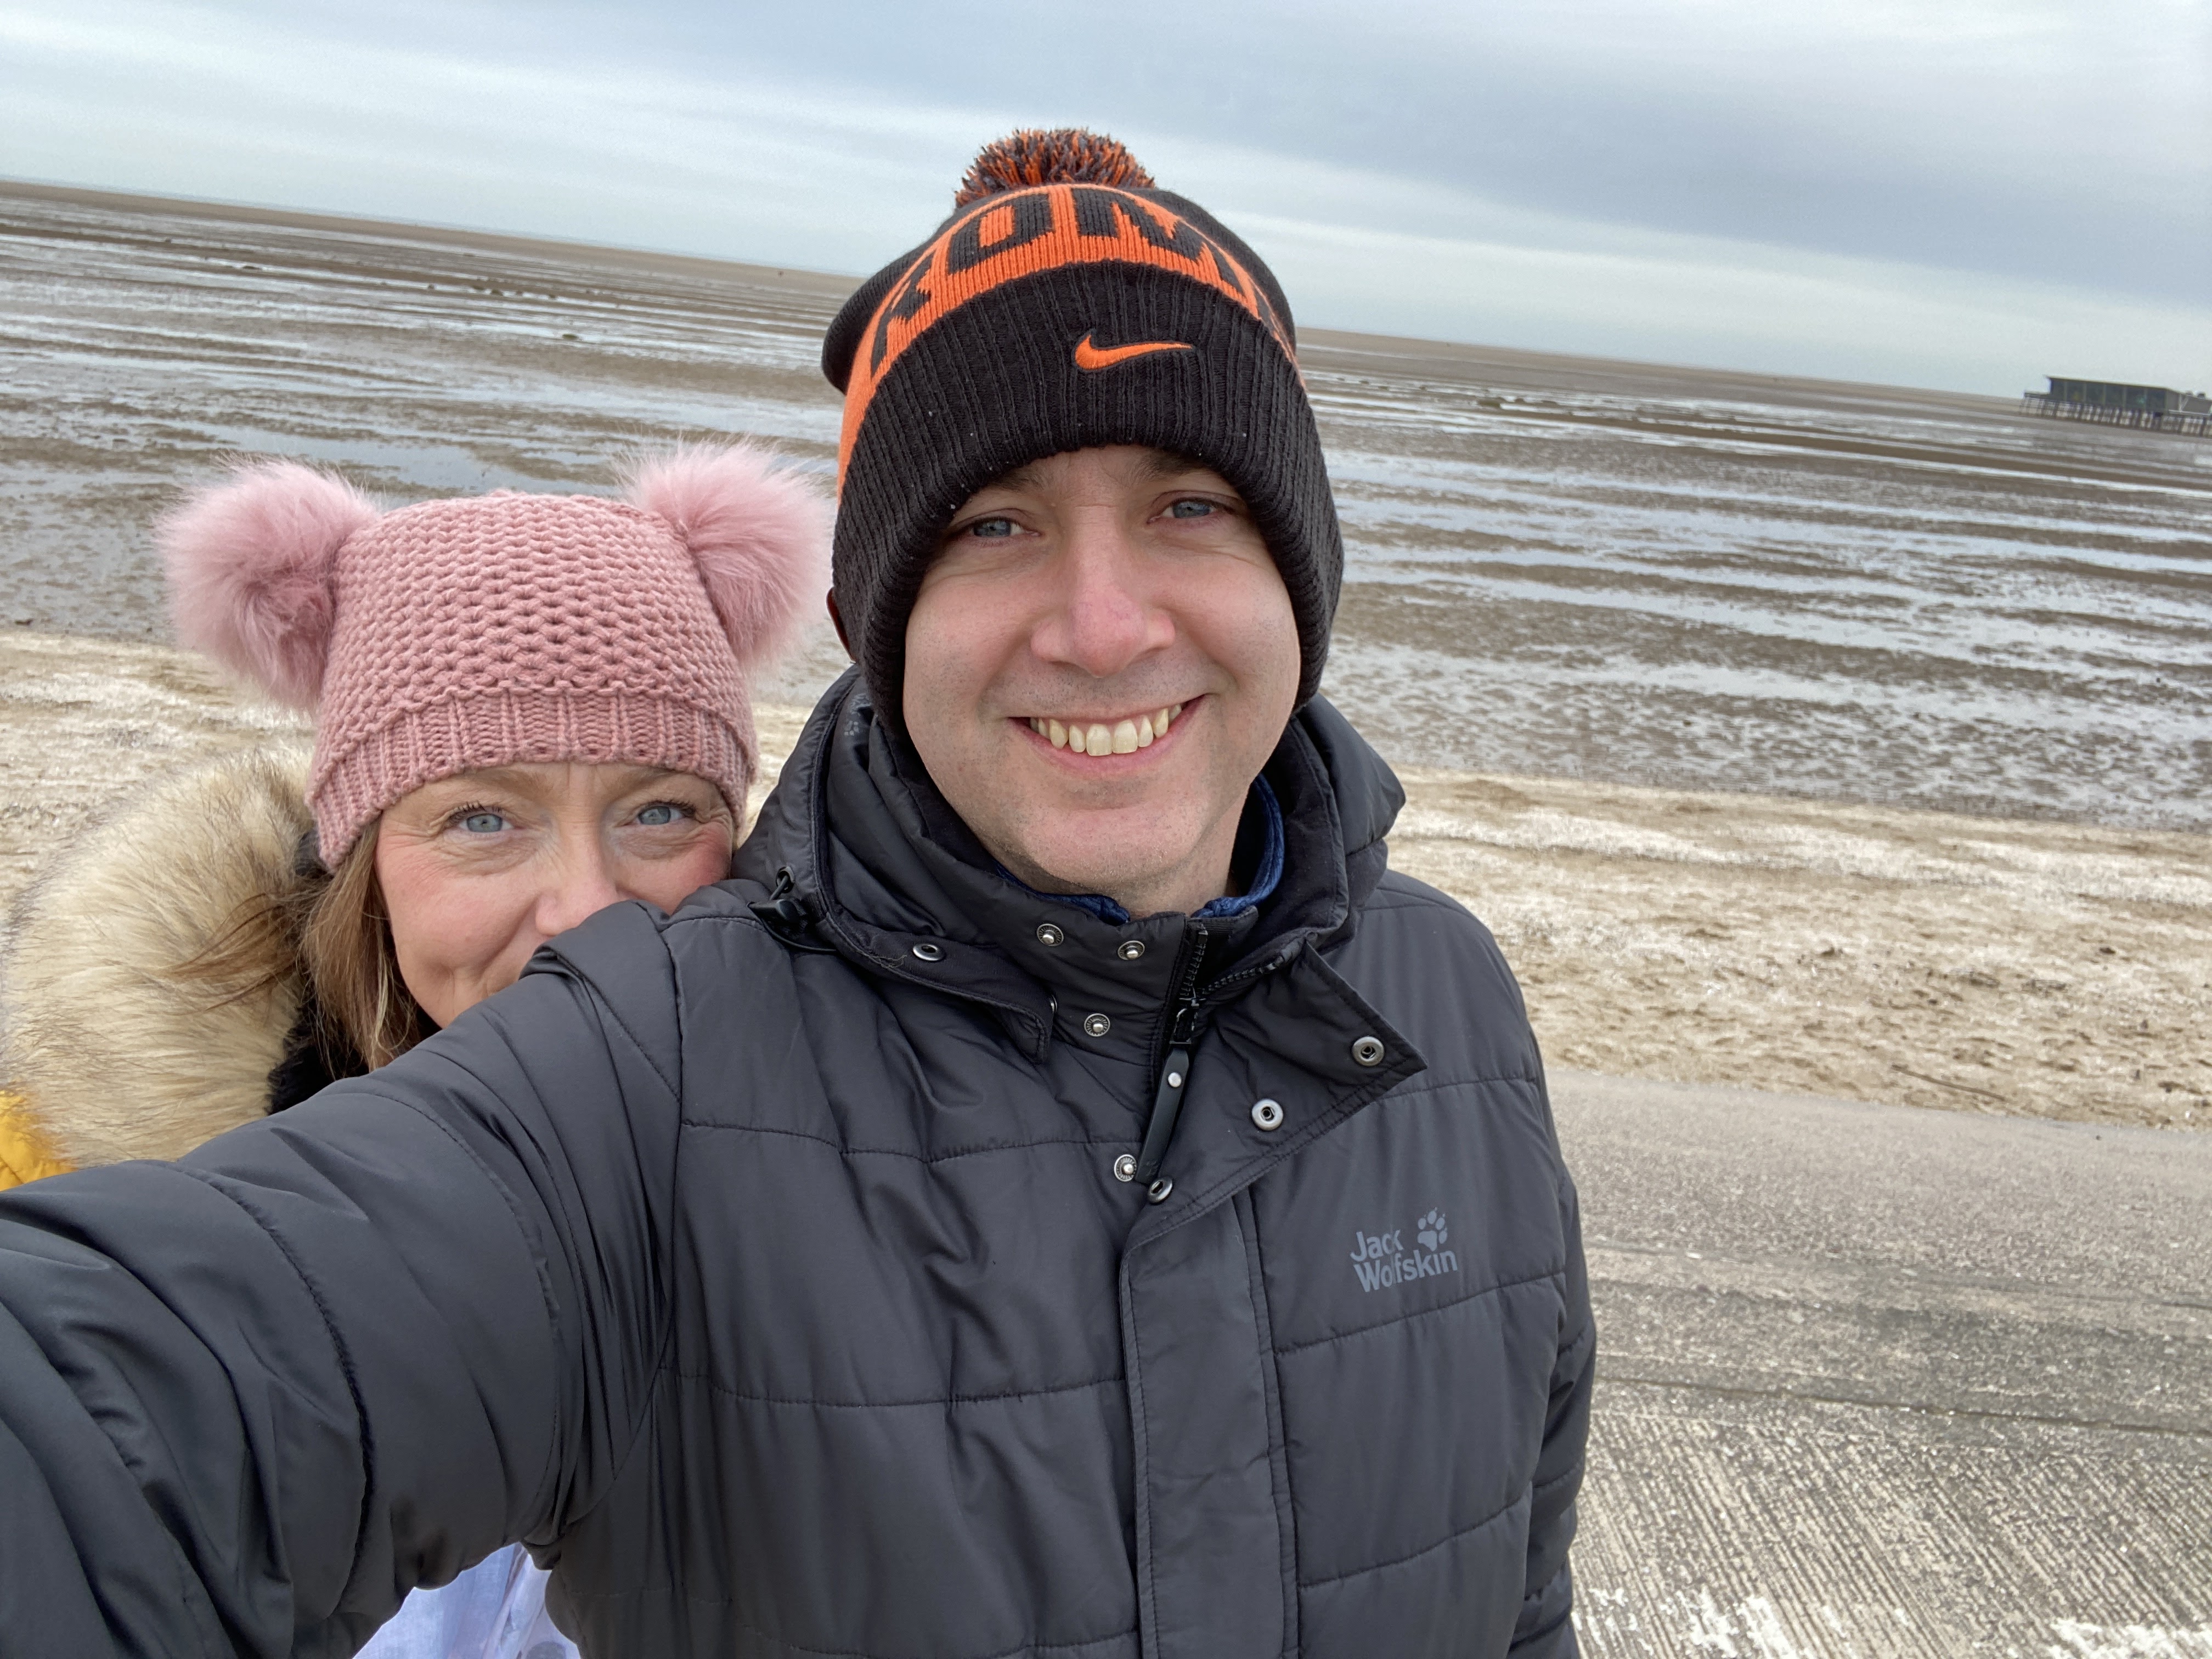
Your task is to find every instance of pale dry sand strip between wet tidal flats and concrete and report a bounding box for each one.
[0,628,2212,1128]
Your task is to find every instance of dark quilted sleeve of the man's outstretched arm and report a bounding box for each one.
[0,907,677,1659]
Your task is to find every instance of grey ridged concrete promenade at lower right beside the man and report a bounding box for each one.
[1553,1073,2212,1659]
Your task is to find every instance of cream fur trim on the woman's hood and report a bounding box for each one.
[0,746,312,1168]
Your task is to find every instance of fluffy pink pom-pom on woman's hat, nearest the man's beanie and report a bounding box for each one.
[628,444,830,673]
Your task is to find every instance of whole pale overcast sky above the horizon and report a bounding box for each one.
[0,0,2212,394]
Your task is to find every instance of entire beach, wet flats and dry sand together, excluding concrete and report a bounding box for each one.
[0,184,2212,1128]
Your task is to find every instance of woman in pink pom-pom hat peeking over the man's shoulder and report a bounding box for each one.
[0,436,827,1659]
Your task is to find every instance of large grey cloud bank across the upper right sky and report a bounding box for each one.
[588,0,2212,301]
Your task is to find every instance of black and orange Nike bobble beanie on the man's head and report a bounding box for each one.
[823,131,1345,721]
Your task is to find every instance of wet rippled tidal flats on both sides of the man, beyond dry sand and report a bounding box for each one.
[0,188,2212,830]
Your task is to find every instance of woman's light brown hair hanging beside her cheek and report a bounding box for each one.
[177,821,433,1077]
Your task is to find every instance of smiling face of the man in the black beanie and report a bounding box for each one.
[905,447,1299,916]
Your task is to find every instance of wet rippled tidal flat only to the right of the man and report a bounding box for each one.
[1310,347,2212,827]
